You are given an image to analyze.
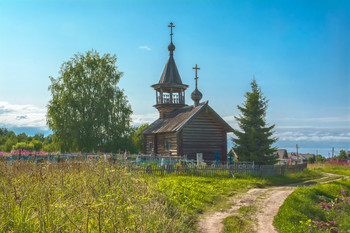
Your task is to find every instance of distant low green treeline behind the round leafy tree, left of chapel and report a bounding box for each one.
[0,124,148,153]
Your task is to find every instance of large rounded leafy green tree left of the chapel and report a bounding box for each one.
[47,50,132,152]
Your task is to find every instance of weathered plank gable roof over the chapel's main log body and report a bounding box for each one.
[140,101,233,134]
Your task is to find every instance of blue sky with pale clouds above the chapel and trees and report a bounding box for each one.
[0,0,350,157]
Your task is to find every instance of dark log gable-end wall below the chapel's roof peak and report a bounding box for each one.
[181,111,227,161]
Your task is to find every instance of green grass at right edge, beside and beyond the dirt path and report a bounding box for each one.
[274,165,350,233]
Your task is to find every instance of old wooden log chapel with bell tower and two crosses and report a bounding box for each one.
[141,23,233,161]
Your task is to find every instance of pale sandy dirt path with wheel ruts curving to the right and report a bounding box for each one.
[198,173,343,233]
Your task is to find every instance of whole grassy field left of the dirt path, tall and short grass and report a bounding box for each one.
[0,161,317,232]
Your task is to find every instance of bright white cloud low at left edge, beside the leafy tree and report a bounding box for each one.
[0,102,47,128]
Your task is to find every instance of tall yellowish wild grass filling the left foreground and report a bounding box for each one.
[0,161,190,232]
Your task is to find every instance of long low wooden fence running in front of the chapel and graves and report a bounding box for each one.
[0,154,307,177]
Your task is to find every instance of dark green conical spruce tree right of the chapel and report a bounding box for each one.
[232,79,277,164]
